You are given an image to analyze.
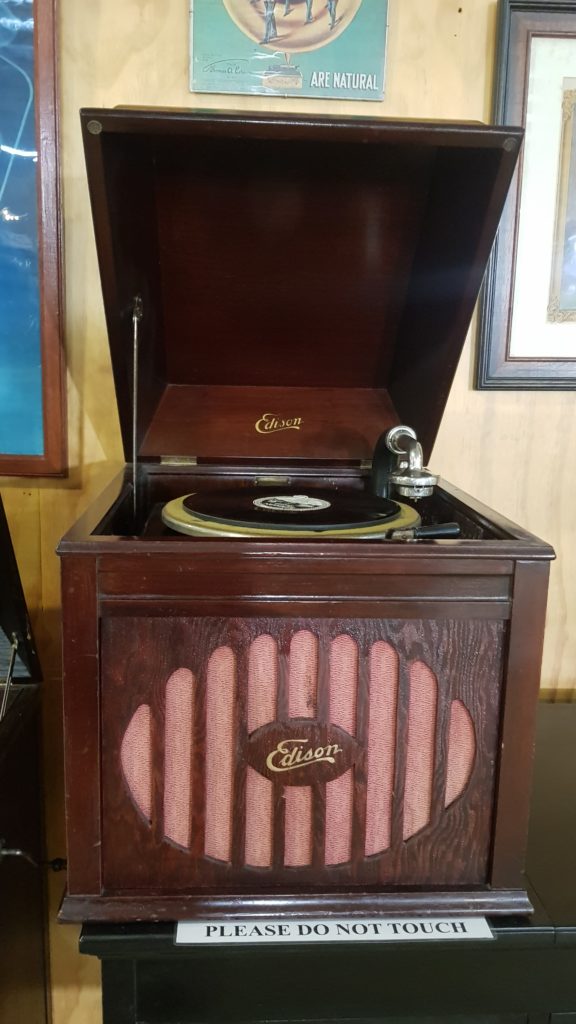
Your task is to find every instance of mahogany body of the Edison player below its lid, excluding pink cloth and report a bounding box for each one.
[57,467,550,918]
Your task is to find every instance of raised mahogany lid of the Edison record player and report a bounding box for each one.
[81,109,522,460]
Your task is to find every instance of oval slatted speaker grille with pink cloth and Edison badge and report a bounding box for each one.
[114,625,478,872]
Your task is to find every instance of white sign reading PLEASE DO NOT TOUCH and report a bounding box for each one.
[175,918,487,946]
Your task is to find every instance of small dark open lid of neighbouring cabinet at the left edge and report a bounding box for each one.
[0,497,42,683]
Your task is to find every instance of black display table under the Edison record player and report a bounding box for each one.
[80,705,576,1024]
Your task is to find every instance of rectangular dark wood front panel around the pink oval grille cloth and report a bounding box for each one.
[101,617,504,895]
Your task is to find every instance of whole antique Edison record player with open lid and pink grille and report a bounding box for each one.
[59,109,552,921]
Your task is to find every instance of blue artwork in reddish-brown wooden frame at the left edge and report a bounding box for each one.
[0,0,67,476]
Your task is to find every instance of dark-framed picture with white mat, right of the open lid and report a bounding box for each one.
[477,0,576,390]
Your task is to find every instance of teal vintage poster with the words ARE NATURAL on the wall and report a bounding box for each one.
[190,0,387,99]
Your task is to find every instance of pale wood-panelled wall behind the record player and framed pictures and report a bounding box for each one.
[0,0,576,1024]
